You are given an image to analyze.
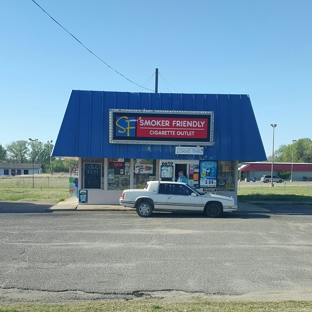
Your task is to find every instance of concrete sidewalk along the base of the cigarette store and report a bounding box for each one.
[50,197,269,212]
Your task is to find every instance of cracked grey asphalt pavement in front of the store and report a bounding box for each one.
[0,202,312,302]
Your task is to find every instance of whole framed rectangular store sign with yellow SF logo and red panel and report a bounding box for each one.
[109,109,214,145]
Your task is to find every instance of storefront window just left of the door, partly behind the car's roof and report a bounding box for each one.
[133,159,156,189]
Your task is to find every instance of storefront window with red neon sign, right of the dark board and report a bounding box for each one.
[108,158,130,190]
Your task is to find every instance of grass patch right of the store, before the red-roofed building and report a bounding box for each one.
[237,186,312,203]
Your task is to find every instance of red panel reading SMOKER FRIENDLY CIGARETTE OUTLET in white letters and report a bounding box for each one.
[136,116,209,139]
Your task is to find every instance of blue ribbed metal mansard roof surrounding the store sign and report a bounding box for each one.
[53,90,266,161]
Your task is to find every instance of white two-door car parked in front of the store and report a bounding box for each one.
[119,181,238,218]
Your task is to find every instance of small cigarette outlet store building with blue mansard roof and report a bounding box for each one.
[53,90,266,204]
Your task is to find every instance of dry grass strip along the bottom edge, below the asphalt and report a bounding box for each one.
[0,299,312,312]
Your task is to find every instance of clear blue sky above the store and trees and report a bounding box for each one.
[0,0,312,156]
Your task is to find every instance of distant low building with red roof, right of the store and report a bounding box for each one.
[238,161,312,181]
